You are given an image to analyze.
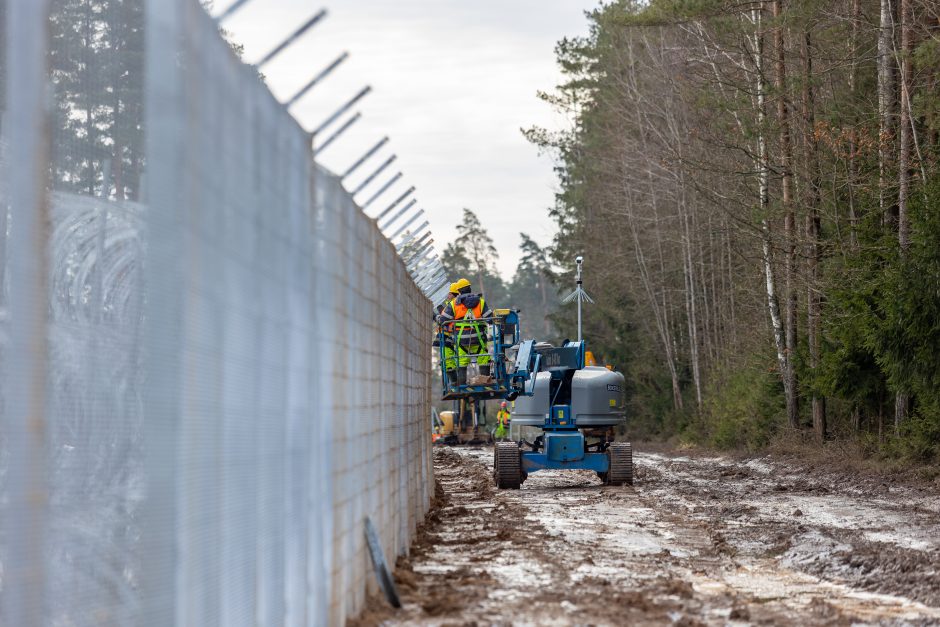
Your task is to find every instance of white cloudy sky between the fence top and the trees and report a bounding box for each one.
[215,0,596,278]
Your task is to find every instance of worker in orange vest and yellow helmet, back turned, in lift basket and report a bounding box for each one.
[438,279,493,385]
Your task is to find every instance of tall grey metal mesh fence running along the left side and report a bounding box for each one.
[0,0,431,626]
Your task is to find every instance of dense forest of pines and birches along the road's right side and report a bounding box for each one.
[525,0,940,463]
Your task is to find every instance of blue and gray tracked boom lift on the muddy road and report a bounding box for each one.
[438,257,633,488]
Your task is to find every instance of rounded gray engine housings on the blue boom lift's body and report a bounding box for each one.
[512,366,627,429]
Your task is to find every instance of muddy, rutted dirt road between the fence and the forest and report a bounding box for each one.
[362,449,940,625]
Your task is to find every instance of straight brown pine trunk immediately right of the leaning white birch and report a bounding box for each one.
[771,0,800,429]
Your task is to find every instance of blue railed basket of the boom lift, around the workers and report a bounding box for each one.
[435,309,521,400]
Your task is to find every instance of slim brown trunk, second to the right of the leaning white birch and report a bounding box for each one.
[800,31,826,441]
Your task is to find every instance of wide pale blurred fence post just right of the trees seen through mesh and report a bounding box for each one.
[141,0,185,627]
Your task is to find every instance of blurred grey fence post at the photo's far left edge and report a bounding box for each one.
[0,0,53,626]
